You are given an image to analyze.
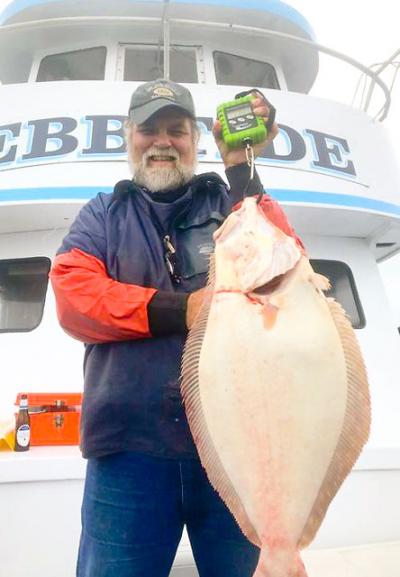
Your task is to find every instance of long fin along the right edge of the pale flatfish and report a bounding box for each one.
[299,298,371,548]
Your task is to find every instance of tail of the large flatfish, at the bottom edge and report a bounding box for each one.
[253,547,308,577]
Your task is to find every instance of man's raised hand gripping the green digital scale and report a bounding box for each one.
[212,93,279,168]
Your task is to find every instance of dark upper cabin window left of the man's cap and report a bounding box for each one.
[36,46,107,82]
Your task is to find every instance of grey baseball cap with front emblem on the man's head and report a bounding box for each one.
[129,78,195,124]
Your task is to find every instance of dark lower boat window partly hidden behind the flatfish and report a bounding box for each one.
[310,259,365,329]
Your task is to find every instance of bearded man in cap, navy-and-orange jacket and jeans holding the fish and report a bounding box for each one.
[51,80,302,577]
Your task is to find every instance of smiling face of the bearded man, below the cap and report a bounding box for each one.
[129,109,197,192]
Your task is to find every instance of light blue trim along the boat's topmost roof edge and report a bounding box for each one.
[0,0,315,40]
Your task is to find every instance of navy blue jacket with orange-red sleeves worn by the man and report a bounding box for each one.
[50,167,302,458]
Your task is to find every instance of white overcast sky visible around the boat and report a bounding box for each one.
[0,0,400,325]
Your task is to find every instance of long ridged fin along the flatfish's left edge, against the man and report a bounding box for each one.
[181,255,261,546]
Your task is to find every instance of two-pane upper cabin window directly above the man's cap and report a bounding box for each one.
[124,46,198,82]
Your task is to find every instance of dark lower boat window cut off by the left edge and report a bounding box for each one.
[0,257,51,333]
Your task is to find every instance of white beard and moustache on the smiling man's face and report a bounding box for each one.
[129,146,197,192]
